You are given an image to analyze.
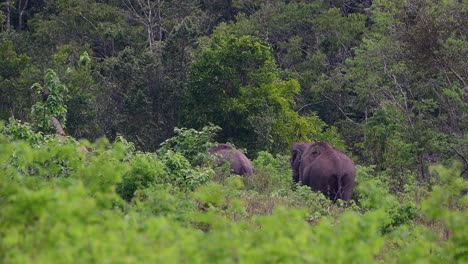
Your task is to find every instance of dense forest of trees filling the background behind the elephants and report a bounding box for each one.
[0,0,468,180]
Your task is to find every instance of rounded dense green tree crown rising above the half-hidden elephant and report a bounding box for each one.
[185,33,280,151]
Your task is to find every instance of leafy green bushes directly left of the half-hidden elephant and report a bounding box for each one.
[116,126,219,201]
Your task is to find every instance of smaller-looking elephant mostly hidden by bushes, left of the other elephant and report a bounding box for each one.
[209,144,253,176]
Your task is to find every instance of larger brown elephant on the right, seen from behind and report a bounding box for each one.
[291,142,356,202]
